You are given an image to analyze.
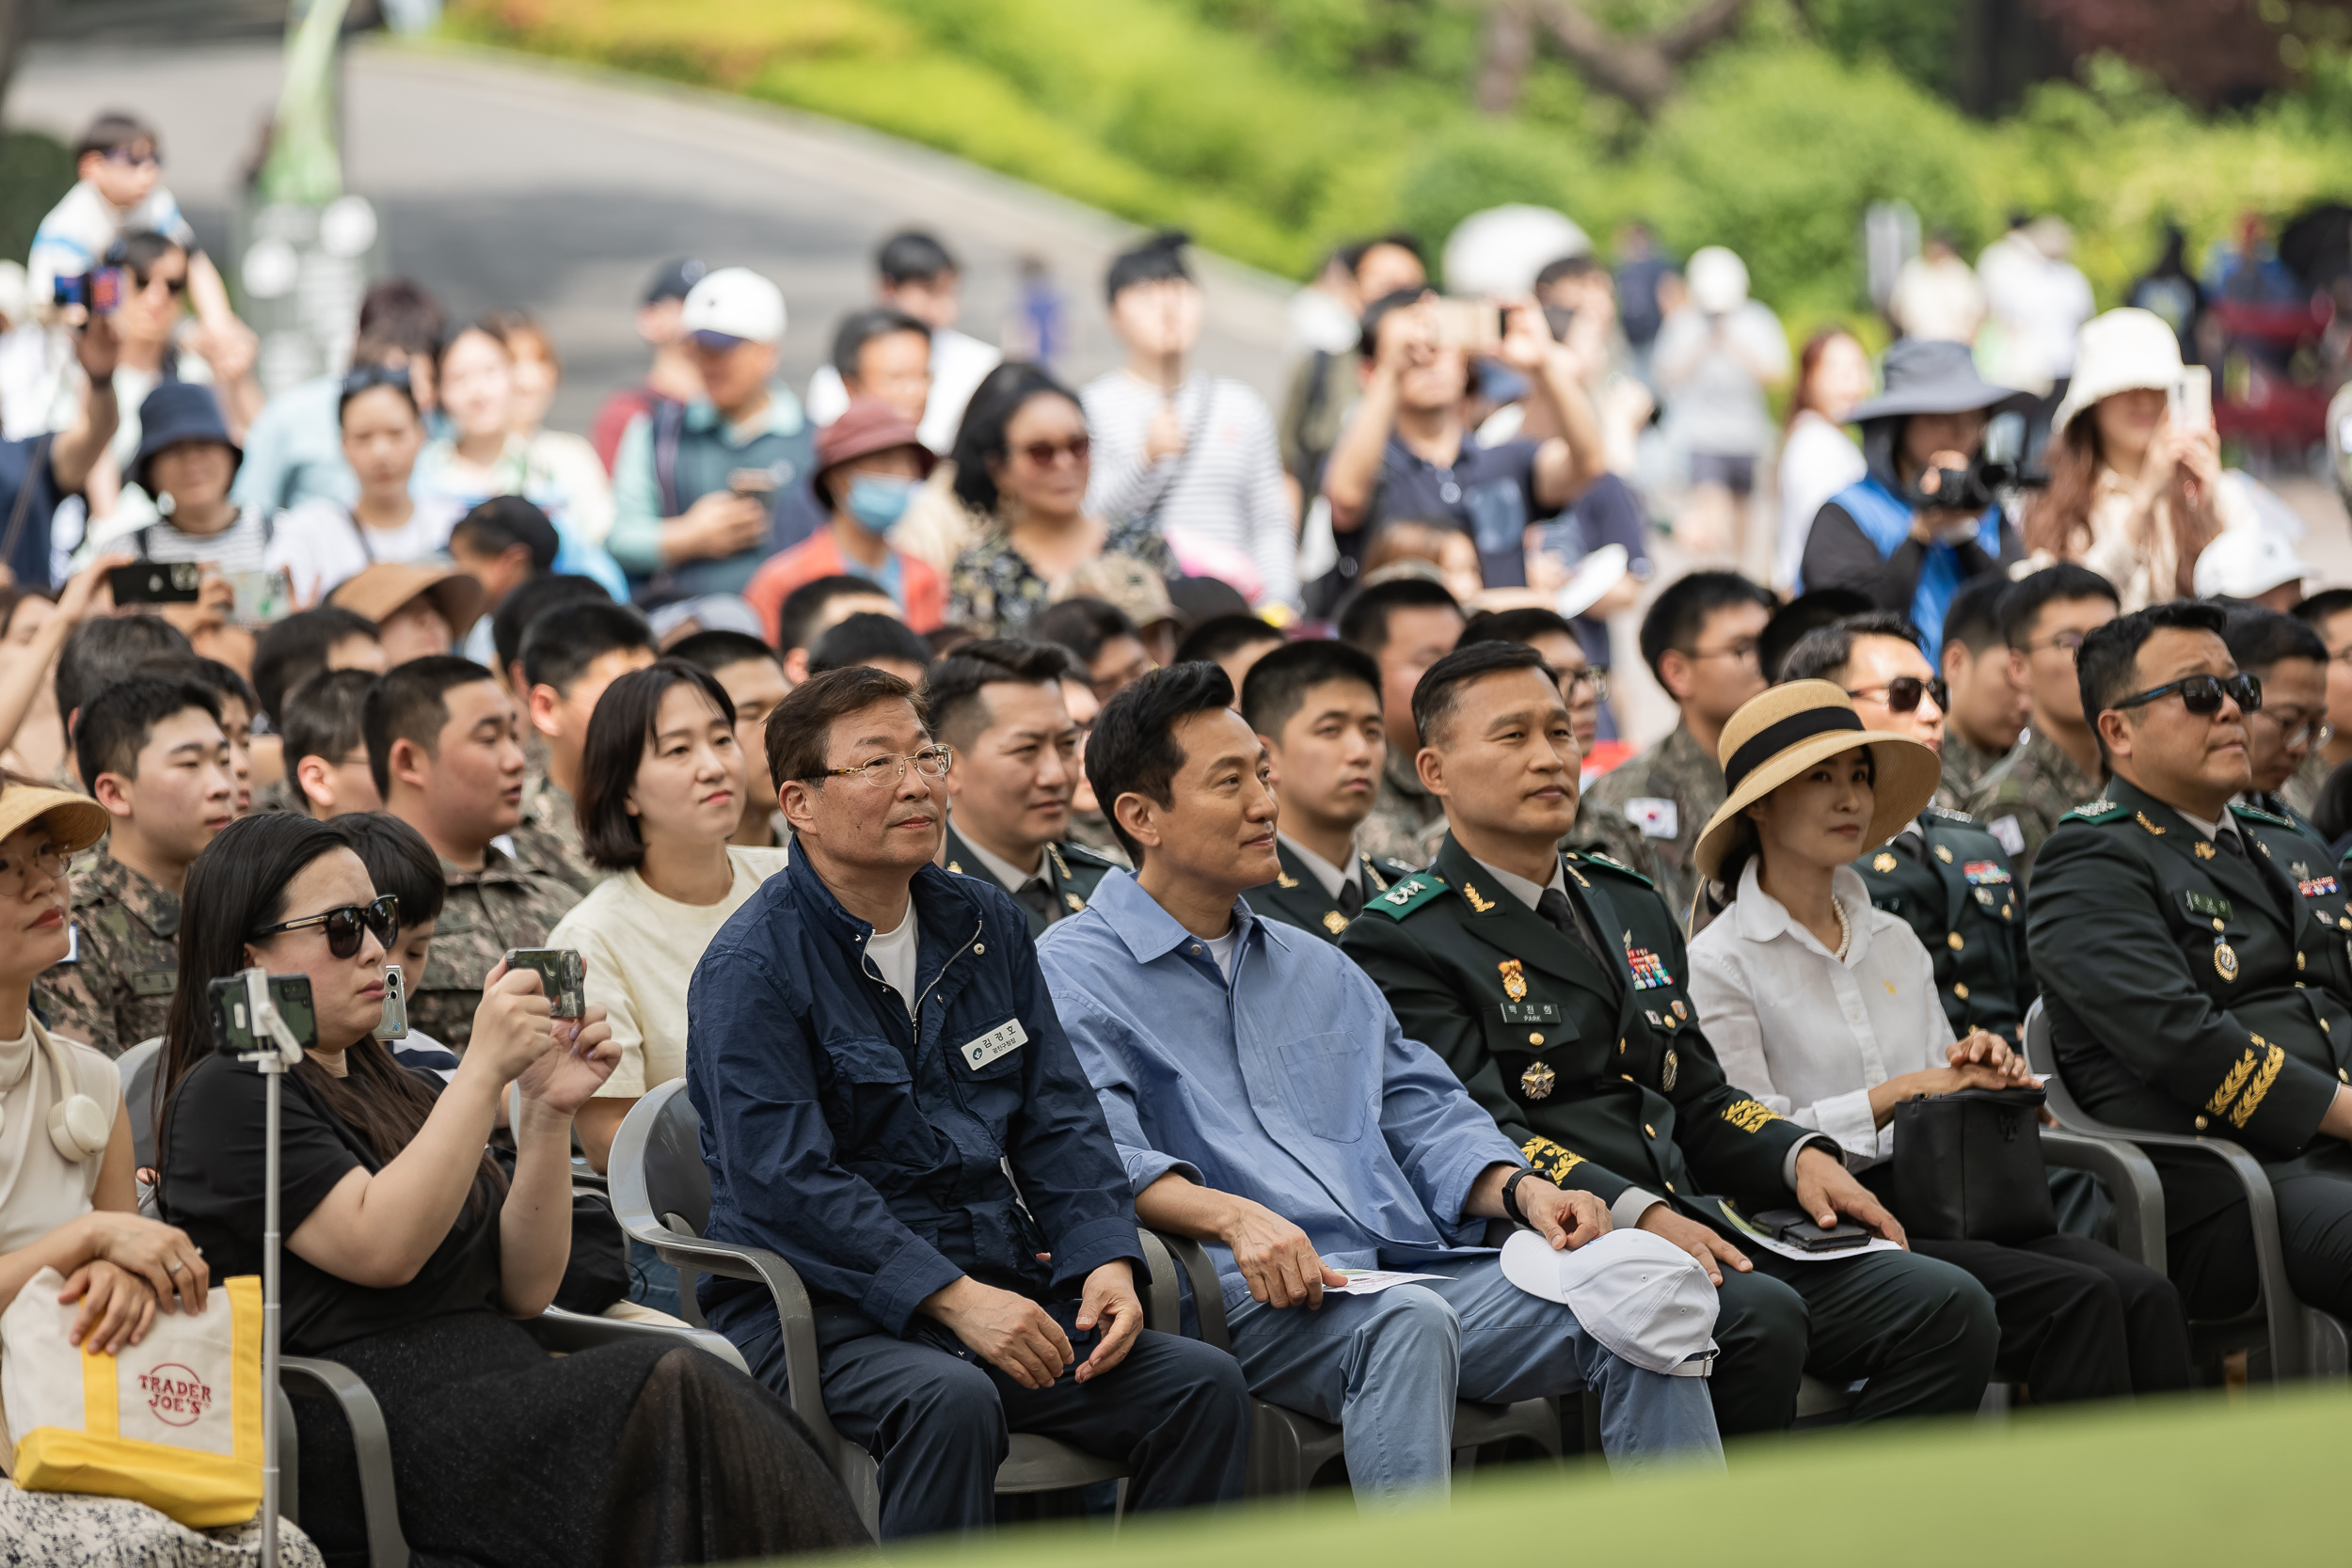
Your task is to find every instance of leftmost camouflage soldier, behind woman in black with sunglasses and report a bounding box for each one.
[33,674,238,1055]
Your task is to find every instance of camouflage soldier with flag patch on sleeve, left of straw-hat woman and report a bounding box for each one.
[1576,571,1773,922]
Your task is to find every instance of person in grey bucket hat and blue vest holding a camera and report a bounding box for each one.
[1797,339,2032,658]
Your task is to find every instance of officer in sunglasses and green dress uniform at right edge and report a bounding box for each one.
[2027,604,2352,1317]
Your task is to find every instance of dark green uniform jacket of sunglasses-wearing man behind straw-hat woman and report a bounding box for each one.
[1853,806,2037,1044]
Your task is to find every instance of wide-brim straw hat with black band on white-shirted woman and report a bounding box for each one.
[1692,679,1943,881]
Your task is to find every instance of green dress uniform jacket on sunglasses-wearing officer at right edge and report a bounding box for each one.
[2027,778,2352,1232]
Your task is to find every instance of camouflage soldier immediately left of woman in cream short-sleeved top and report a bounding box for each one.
[367,648,579,1051]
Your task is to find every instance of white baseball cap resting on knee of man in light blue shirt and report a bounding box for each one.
[1503,1229,1715,1378]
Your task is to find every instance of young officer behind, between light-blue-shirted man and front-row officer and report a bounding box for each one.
[1242,640,1414,942]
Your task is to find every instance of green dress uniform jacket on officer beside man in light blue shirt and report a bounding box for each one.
[1341,834,1819,1239]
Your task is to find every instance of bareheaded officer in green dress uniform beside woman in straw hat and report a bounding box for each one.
[1341,644,1999,1434]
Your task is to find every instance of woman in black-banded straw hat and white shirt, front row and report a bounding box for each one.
[1692,679,2190,1403]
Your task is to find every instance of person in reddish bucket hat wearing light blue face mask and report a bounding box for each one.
[743,397,948,635]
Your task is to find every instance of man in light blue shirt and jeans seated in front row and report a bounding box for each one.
[1038,663,1722,1500]
